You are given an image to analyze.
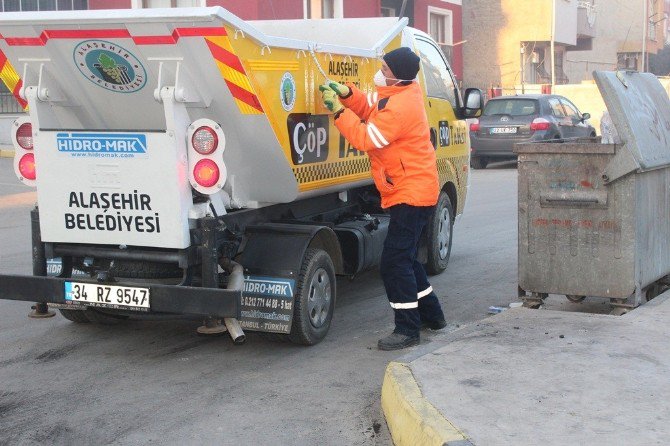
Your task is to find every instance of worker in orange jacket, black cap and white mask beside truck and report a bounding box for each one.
[319,47,447,350]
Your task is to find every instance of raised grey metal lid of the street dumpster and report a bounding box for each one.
[593,71,670,171]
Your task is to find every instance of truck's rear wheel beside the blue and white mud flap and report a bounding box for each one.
[289,248,336,345]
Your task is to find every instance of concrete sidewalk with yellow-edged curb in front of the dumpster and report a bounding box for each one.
[382,292,670,446]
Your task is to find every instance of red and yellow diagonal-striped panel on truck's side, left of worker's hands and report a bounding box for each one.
[205,35,263,115]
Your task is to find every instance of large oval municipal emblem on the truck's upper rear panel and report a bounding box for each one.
[73,40,147,93]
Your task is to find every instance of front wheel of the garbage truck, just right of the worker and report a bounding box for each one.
[425,191,454,276]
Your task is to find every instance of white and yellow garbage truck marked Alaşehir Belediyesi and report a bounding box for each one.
[0,7,482,345]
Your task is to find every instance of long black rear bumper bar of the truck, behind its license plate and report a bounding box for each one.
[0,275,242,319]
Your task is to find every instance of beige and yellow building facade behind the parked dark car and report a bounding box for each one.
[463,0,667,95]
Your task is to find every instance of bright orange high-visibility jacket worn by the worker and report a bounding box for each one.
[335,82,440,208]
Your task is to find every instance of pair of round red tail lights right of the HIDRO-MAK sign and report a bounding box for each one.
[188,119,228,195]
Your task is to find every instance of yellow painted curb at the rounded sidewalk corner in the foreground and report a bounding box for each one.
[382,362,472,446]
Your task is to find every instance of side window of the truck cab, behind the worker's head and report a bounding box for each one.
[416,39,458,108]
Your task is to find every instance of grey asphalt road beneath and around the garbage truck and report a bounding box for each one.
[0,158,606,445]
